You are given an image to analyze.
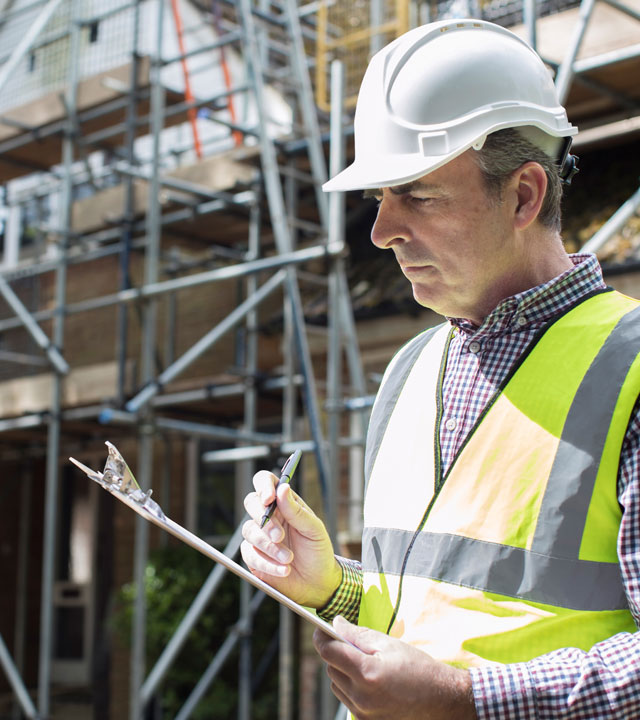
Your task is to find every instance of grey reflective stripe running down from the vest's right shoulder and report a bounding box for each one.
[531,307,640,559]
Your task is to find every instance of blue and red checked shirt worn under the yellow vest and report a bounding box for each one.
[319,254,640,720]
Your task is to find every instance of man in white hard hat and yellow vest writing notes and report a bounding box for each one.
[242,20,640,720]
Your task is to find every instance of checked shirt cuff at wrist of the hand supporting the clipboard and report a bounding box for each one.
[469,663,538,720]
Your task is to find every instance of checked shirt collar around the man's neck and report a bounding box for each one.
[448,253,607,335]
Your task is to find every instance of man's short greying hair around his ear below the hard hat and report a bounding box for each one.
[473,128,562,231]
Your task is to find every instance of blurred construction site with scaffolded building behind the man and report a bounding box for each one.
[0,0,640,720]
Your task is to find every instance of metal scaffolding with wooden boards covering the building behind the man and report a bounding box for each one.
[0,0,640,720]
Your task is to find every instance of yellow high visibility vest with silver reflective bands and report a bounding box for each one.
[359,291,640,667]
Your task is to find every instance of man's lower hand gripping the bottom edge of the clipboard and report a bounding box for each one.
[313,617,477,720]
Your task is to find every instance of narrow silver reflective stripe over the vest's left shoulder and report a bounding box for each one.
[364,325,442,484]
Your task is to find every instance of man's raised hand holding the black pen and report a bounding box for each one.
[240,470,342,608]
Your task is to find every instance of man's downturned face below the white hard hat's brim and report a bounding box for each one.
[365,150,527,324]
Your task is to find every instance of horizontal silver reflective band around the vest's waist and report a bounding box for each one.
[362,528,628,611]
